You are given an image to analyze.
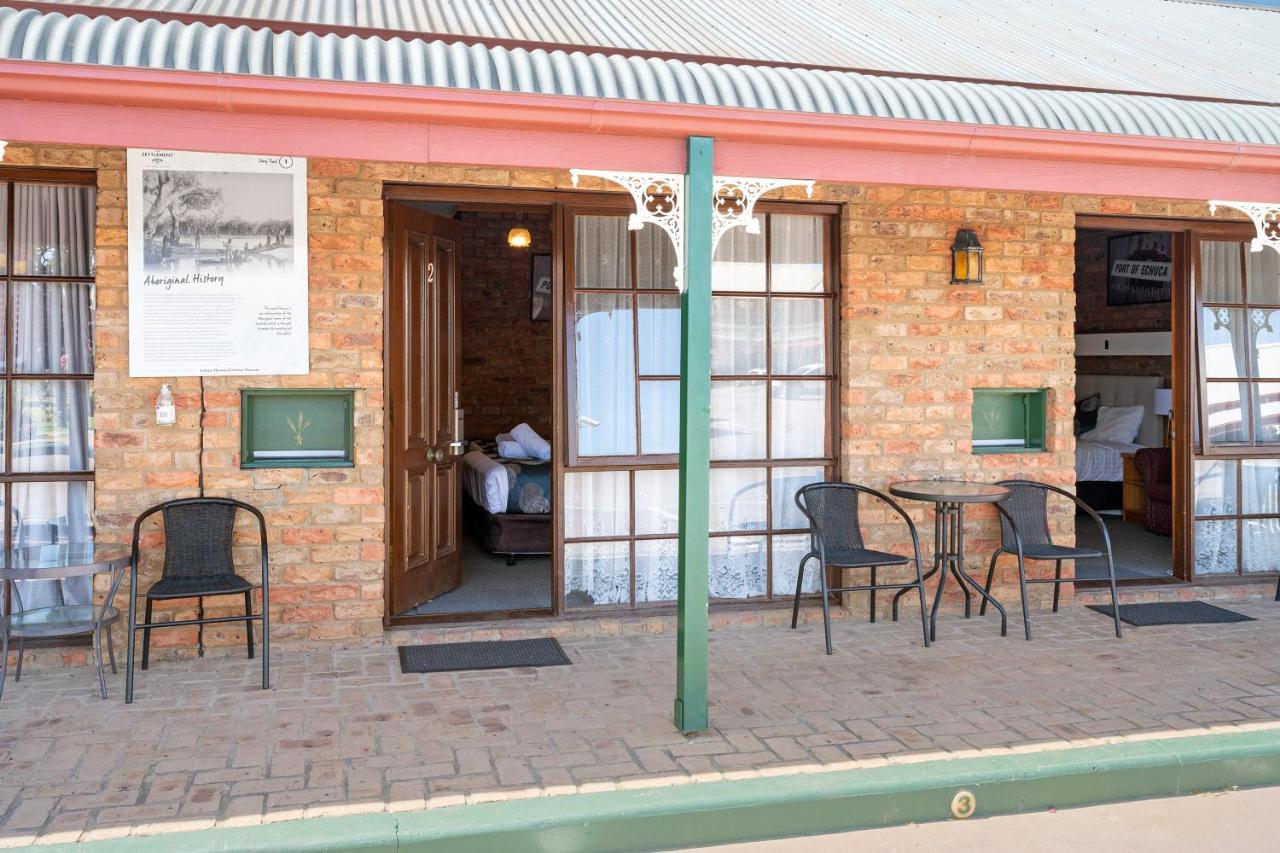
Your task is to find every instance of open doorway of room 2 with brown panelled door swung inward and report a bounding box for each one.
[388,195,556,620]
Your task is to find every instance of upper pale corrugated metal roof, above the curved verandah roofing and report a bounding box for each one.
[30,0,1280,101]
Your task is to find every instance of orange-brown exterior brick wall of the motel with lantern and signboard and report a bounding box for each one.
[5,143,1239,654]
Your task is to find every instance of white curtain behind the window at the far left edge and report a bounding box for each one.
[6,184,96,608]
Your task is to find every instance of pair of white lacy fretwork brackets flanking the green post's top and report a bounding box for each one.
[570,169,813,292]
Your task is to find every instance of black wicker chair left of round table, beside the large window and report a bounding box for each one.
[791,483,929,654]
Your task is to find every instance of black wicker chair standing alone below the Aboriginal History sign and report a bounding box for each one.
[124,498,270,702]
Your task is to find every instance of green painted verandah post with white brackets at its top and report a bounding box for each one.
[676,136,716,731]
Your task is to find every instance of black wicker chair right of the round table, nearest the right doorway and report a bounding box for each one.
[978,480,1120,639]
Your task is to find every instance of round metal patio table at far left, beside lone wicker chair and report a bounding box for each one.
[0,543,129,699]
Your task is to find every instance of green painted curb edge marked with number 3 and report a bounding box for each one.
[35,730,1280,853]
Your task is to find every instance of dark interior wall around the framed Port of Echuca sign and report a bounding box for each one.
[1075,228,1172,383]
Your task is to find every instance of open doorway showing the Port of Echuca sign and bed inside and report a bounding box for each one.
[1075,223,1185,583]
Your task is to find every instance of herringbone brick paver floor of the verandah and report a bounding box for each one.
[0,602,1280,845]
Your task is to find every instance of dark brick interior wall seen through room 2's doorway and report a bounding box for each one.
[458,211,552,438]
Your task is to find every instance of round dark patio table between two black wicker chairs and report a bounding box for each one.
[888,480,1009,639]
